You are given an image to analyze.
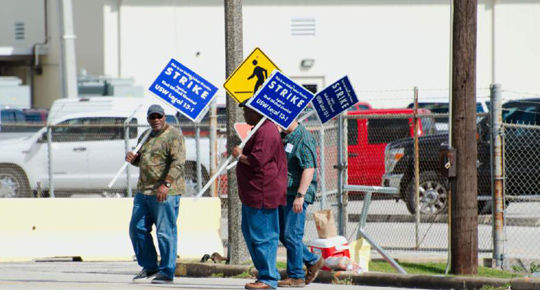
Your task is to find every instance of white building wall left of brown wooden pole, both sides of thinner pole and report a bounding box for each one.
[116,0,458,106]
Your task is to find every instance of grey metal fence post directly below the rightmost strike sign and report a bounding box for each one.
[336,114,347,236]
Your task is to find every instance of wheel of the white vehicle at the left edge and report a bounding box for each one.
[0,166,32,198]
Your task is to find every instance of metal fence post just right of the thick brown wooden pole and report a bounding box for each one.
[490,84,505,266]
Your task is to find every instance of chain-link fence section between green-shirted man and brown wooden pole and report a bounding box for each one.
[346,109,462,256]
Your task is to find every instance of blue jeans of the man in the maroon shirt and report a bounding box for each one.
[242,205,281,288]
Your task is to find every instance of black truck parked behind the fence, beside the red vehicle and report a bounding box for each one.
[382,98,540,214]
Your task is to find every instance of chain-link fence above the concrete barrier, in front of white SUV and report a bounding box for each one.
[0,116,213,197]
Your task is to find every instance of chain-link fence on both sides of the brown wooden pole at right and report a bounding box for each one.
[332,90,540,266]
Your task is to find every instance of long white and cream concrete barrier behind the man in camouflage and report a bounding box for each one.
[0,197,223,262]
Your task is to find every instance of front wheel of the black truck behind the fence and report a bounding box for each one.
[405,171,448,215]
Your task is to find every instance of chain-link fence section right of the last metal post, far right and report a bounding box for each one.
[503,121,540,262]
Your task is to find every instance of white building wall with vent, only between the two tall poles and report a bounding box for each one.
[244,1,450,107]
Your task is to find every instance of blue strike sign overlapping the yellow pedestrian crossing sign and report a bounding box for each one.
[246,70,314,129]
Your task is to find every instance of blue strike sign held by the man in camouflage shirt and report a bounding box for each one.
[149,58,217,122]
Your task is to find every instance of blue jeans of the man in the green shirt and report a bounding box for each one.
[279,196,319,279]
